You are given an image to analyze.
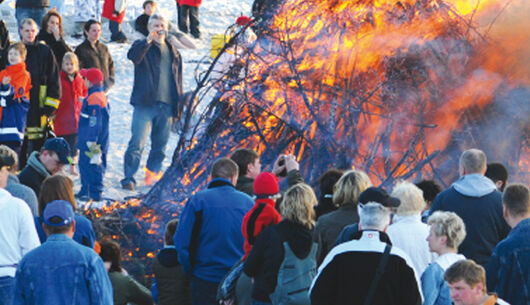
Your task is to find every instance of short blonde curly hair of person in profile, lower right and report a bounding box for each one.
[427,211,466,250]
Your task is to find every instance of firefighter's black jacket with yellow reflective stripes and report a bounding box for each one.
[26,42,61,140]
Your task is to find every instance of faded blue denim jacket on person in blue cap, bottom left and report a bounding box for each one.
[13,234,113,305]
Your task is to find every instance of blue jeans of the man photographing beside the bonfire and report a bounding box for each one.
[121,102,173,185]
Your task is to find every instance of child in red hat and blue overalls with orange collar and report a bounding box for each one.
[77,68,109,201]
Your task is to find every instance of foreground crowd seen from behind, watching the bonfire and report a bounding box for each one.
[0,143,530,305]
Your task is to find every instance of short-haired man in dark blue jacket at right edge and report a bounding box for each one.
[486,183,530,305]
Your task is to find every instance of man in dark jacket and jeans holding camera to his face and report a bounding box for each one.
[121,14,182,190]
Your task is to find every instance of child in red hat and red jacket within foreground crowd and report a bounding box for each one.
[242,172,282,259]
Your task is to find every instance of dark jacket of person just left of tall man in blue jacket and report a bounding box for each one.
[152,246,191,305]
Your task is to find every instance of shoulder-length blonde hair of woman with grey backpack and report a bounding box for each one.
[281,183,317,229]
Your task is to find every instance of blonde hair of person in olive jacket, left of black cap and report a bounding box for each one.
[333,170,372,206]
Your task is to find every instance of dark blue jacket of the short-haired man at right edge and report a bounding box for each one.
[486,218,530,305]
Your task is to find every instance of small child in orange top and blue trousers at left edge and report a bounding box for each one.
[0,42,31,154]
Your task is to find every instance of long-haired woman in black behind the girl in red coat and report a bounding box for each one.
[37,10,72,68]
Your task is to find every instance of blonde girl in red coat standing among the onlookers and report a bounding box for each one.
[53,52,87,175]
